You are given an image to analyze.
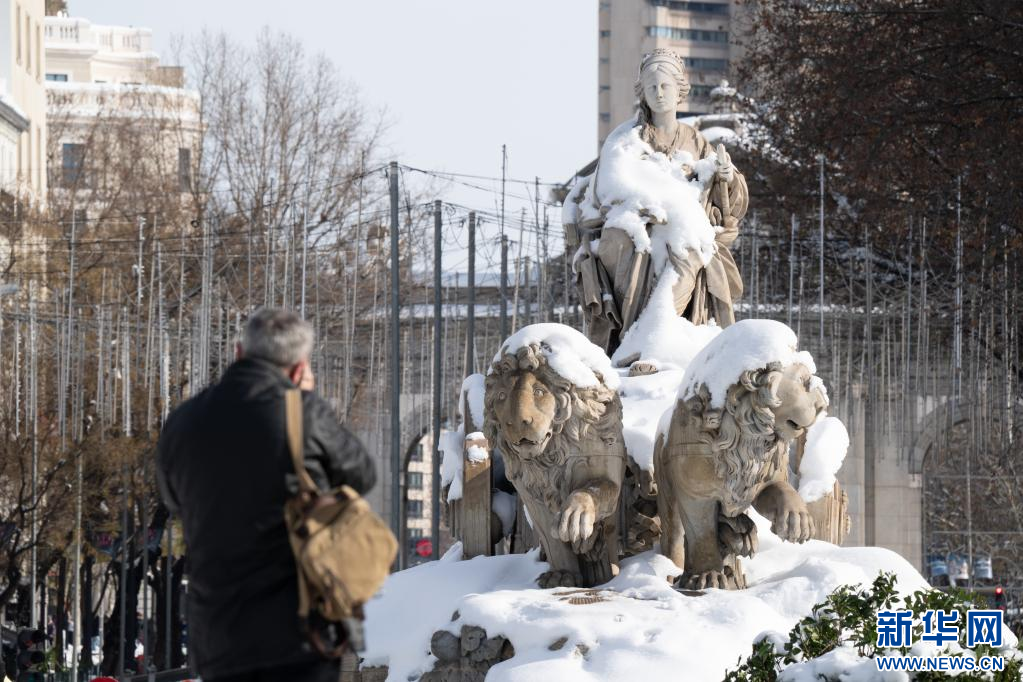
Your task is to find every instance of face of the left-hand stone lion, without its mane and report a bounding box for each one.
[493,371,558,459]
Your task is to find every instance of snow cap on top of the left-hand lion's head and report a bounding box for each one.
[491,322,618,388]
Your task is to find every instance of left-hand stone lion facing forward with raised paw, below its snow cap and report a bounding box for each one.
[483,343,625,588]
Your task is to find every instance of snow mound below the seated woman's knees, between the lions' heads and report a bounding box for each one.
[611,268,721,369]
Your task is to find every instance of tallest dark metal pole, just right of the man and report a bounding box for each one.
[388,162,403,548]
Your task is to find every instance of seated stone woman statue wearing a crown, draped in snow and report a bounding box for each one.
[563,49,749,364]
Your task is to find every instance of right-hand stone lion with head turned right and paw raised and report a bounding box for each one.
[654,362,828,589]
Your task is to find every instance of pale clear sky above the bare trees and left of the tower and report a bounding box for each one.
[69,0,597,269]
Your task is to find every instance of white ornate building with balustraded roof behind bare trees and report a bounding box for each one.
[45,15,203,203]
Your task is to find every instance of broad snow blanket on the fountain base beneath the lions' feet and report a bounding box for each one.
[363,514,928,682]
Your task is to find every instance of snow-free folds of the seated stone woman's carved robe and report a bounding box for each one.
[566,123,749,365]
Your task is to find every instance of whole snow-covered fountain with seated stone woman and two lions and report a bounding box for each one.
[353,50,1014,681]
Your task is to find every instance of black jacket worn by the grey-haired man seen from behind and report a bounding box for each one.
[157,359,376,678]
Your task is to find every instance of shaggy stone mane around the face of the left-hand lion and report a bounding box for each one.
[483,344,622,513]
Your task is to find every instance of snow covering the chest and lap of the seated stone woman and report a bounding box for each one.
[585,120,717,273]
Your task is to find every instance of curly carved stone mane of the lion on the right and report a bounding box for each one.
[687,363,788,508]
